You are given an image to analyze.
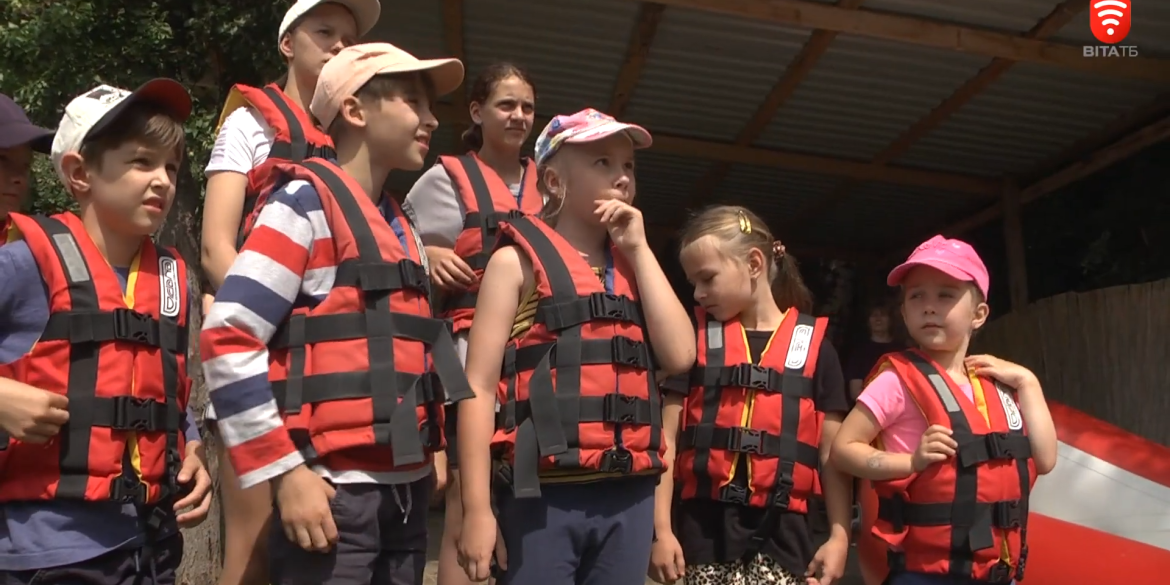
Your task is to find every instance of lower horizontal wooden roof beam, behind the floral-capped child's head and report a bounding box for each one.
[434,103,1002,193]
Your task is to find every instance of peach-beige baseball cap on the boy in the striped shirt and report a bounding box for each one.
[309,42,463,129]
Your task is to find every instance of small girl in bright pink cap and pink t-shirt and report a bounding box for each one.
[833,235,1057,585]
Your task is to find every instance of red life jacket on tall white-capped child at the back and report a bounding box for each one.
[220,83,333,249]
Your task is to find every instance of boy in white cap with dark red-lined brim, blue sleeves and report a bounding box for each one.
[0,80,211,585]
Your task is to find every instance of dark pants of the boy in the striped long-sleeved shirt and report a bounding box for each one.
[268,476,434,585]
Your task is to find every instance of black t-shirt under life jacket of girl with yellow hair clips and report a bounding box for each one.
[674,331,849,576]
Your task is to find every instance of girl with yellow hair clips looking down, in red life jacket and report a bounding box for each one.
[649,206,851,585]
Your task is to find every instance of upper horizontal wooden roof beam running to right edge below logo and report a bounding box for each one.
[658,0,1170,83]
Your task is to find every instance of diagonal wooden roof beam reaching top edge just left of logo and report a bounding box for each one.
[789,0,1089,231]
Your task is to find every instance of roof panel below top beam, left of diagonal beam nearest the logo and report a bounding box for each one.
[757,35,987,160]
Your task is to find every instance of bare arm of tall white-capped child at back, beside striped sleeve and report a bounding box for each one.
[200,171,248,289]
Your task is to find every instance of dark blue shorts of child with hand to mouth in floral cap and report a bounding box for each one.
[496,476,658,585]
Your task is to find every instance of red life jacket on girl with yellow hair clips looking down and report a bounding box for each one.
[676,308,828,514]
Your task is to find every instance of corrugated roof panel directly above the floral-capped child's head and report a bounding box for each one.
[626,8,810,142]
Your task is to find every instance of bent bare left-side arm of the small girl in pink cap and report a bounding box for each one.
[831,402,914,481]
